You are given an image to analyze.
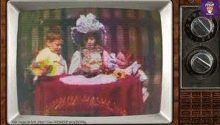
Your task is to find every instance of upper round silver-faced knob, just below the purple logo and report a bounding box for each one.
[191,16,214,38]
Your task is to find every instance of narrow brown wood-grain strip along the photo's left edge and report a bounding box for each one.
[0,0,6,125]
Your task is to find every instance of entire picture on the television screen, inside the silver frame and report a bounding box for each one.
[17,8,162,116]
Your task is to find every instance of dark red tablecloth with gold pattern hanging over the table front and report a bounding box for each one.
[35,76,143,116]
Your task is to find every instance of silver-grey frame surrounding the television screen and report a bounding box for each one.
[6,0,174,124]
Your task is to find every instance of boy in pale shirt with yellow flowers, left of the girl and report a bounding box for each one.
[31,27,67,81]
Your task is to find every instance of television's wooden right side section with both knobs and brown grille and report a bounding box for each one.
[179,0,220,125]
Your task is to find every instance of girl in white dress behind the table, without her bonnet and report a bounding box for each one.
[69,32,102,76]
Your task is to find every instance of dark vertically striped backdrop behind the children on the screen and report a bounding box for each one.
[17,8,162,114]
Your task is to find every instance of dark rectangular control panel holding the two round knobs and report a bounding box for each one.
[180,6,220,89]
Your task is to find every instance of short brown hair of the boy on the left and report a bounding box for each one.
[46,26,62,42]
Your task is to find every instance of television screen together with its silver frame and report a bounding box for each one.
[6,0,174,124]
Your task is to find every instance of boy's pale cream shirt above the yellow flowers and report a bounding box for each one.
[34,47,67,80]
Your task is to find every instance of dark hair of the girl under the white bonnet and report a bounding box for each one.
[83,31,101,45]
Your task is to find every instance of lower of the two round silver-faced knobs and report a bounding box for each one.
[190,51,214,74]
